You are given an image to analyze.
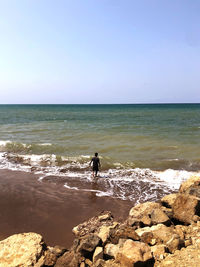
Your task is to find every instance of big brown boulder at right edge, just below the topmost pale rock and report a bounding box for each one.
[172,194,200,224]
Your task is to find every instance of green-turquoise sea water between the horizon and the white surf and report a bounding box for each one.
[0,104,200,170]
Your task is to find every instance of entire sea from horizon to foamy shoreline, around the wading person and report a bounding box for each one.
[0,104,200,203]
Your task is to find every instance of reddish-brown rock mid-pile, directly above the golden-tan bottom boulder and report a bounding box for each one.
[110,224,140,244]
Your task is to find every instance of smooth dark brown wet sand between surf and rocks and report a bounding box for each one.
[0,170,134,248]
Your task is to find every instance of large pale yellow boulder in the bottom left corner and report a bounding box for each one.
[0,233,45,267]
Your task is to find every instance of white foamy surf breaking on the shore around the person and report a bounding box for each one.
[0,141,200,203]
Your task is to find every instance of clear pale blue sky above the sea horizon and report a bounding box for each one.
[0,0,200,104]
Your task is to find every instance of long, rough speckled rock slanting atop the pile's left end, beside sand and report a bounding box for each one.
[72,211,113,237]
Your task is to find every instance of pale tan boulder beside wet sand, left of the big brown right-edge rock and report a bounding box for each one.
[127,202,166,226]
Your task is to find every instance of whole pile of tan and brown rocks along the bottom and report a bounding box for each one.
[0,177,200,267]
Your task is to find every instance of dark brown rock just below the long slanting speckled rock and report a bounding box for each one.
[77,234,100,255]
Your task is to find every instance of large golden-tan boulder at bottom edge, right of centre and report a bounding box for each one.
[116,239,152,267]
